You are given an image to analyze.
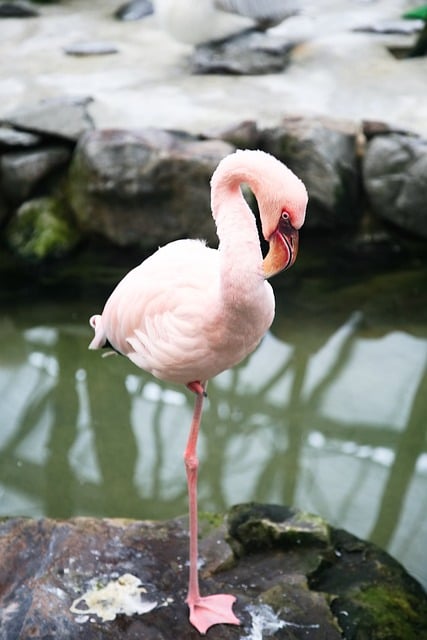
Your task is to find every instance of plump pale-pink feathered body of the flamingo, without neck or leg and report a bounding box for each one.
[91,240,274,384]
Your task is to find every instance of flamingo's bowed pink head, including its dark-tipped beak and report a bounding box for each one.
[259,165,308,278]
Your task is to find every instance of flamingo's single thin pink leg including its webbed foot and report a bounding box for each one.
[184,382,240,635]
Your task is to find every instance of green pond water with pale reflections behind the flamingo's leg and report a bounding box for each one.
[0,252,427,586]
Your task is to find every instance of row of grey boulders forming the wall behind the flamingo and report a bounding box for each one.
[0,98,427,276]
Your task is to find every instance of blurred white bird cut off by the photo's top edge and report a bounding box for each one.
[154,0,299,45]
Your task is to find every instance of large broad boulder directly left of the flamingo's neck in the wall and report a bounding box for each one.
[69,129,233,250]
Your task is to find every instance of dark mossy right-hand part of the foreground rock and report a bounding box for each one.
[228,503,427,640]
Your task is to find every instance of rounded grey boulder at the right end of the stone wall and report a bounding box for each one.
[363,133,427,238]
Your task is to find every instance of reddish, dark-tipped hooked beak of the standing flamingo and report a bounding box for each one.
[263,212,298,278]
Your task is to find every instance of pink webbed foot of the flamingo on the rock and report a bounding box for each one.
[187,593,241,635]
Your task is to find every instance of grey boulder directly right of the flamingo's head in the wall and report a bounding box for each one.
[260,117,361,230]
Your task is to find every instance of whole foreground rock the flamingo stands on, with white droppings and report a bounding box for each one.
[0,504,427,640]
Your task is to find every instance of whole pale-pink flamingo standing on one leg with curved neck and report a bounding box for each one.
[89,150,307,635]
